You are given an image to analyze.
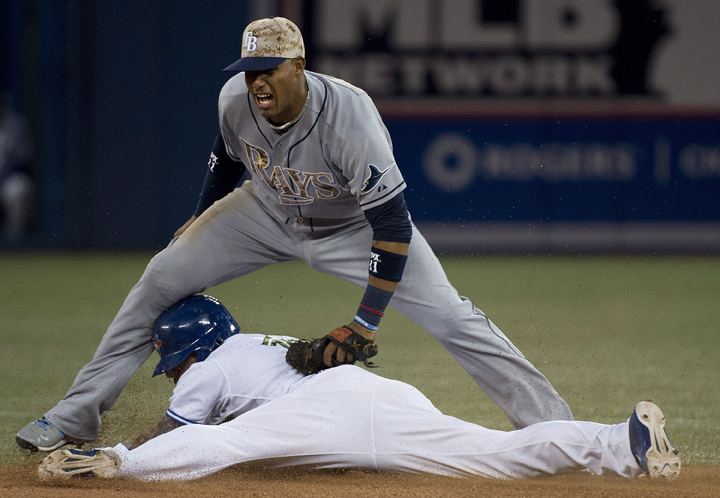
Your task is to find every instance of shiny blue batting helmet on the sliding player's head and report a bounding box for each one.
[152,295,240,377]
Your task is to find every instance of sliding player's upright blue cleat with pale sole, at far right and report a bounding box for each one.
[628,401,680,479]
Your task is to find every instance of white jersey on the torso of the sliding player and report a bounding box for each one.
[167,334,308,425]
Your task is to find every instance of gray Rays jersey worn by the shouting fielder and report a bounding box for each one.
[219,71,405,219]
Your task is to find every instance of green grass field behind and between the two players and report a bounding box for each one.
[0,253,720,465]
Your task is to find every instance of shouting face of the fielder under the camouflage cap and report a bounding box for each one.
[245,57,307,125]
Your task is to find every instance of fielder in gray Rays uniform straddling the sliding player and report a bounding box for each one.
[16,17,572,451]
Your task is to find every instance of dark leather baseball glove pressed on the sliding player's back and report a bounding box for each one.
[285,327,378,375]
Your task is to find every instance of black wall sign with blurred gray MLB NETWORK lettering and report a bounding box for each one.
[310,0,668,98]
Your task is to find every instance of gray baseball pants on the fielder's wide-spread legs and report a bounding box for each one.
[46,182,572,440]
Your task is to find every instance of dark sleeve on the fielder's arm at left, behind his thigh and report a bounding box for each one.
[195,133,245,216]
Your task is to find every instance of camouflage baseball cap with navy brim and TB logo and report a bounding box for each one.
[223,17,305,72]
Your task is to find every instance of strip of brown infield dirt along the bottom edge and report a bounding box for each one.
[0,465,720,498]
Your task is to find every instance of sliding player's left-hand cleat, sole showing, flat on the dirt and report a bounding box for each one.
[38,450,118,481]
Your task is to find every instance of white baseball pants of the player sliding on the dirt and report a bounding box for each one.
[113,366,642,480]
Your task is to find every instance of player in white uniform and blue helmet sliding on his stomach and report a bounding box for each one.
[38,296,680,480]
